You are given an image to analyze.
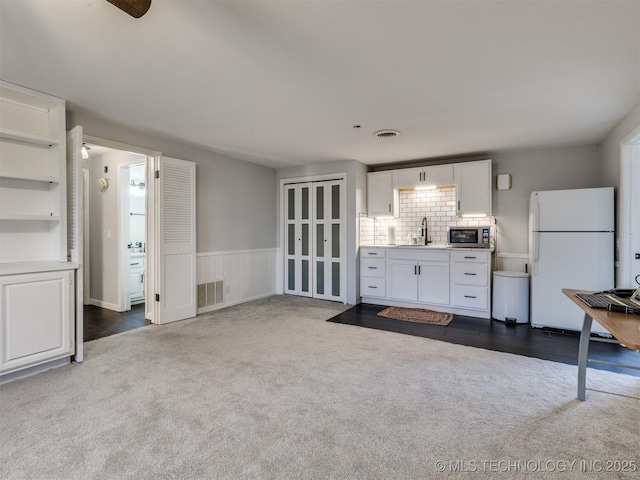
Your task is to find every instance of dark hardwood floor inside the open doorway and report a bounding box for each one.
[83,303,151,342]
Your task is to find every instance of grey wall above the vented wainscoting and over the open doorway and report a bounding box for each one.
[67,105,277,252]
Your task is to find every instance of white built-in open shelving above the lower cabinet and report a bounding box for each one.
[0,82,67,263]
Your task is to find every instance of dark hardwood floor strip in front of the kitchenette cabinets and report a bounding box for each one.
[328,303,640,377]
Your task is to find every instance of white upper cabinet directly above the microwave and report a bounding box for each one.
[453,160,492,215]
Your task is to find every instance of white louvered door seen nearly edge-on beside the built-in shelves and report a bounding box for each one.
[67,126,84,362]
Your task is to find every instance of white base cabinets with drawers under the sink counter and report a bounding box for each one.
[360,246,491,318]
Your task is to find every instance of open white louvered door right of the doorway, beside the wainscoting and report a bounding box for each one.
[155,157,197,323]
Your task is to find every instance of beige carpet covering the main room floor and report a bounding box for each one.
[0,297,640,480]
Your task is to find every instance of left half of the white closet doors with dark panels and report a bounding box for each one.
[285,183,313,297]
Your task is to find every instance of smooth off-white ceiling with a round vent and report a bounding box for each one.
[0,0,640,168]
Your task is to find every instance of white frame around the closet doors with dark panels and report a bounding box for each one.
[276,172,348,304]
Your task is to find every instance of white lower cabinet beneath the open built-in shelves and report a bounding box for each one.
[0,270,75,374]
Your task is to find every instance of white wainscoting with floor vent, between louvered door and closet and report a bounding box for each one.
[196,248,276,313]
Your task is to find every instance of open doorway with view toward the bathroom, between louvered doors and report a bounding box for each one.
[82,135,155,336]
